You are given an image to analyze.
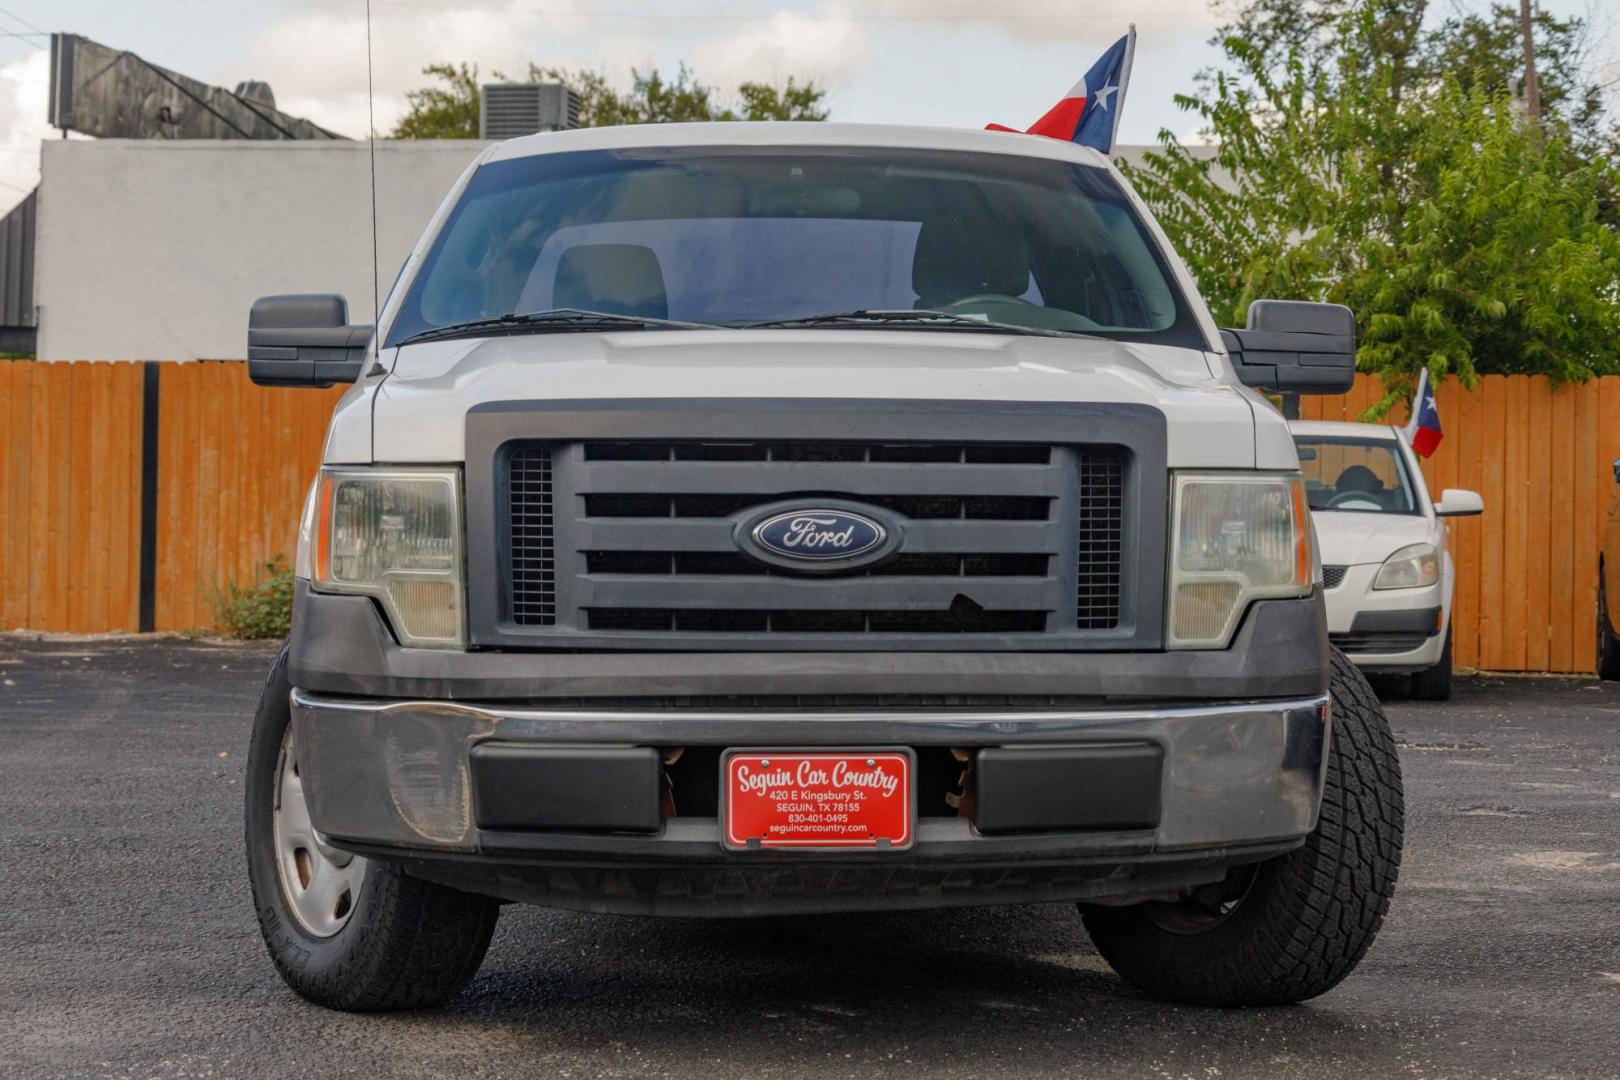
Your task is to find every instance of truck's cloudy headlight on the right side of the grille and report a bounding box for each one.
[1166,473,1314,649]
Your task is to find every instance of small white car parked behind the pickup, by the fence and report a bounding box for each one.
[1290,419,1486,701]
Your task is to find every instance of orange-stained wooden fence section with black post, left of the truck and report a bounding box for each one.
[0,361,342,633]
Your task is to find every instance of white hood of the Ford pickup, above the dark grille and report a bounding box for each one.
[364,330,1276,468]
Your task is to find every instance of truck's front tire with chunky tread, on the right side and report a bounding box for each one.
[1082,649,1405,1006]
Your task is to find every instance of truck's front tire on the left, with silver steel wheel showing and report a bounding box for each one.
[246,648,499,1012]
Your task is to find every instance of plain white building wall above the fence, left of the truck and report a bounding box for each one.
[36,139,484,359]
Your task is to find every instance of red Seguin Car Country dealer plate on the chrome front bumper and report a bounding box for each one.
[721,750,915,848]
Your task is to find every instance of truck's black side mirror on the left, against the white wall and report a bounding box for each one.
[248,293,371,387]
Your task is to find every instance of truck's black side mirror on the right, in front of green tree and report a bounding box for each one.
[1220,300,1356,393]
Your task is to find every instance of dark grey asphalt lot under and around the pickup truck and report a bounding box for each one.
[0,636,1620,1080]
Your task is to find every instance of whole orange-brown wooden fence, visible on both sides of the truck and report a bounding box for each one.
[0,361,1620,672]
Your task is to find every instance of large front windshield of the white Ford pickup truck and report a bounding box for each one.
[387,147,1202,348]
